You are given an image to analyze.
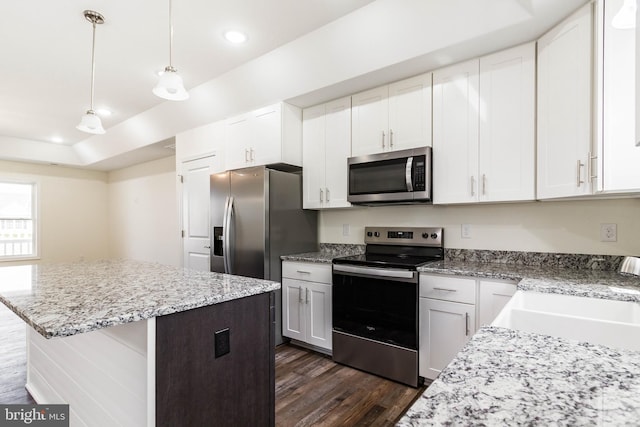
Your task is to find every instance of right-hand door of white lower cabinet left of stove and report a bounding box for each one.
[305,282,332,350]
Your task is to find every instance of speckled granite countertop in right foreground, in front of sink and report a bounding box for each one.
[398,326,640,427]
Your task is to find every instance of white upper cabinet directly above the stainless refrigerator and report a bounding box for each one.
[225,103,302,170]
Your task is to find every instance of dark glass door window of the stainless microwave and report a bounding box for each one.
[349,157,407,195]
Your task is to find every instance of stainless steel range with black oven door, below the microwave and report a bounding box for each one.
[332,227,444,387]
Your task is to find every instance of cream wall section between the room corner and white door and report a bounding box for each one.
[108,156,181,266]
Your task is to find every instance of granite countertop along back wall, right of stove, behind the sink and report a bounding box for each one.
[419,260,640,302]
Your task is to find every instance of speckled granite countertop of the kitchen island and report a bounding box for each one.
[0,260,280,338]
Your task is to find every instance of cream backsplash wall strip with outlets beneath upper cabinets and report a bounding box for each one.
[319,199,640,256]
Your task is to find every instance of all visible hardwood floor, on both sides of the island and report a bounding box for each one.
[0,304,425,427]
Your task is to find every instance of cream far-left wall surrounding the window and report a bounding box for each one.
[0,161,108,265]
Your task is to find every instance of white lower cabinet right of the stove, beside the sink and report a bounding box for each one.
[418,274,516,379]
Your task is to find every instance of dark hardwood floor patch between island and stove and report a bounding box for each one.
[276,345,426,427]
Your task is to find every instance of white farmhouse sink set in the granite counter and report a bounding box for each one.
[491,291,640,350]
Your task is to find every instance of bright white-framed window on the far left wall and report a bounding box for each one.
[0,181,38,261]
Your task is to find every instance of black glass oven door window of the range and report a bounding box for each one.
[332,274,418,350]
